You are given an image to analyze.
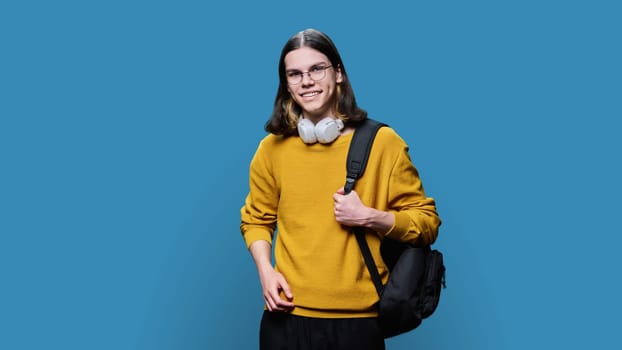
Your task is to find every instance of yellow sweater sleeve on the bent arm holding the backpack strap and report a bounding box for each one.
[386,136,441,245]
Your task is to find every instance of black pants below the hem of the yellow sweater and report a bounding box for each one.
[259,311,385,350]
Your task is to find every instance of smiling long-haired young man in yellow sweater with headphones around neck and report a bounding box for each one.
[241,29,440,350]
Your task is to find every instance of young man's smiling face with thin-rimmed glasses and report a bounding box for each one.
[284,47,343,122]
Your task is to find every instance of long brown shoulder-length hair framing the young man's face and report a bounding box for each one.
[265,29,367,136]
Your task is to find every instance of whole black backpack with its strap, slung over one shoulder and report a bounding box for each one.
[344,119,446,338]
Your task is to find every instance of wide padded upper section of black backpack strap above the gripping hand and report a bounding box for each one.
[343,118,386,194]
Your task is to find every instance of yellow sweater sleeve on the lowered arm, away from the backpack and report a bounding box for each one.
[240,139,279,247]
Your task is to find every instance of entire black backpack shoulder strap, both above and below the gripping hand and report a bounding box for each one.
[343,119,386,295]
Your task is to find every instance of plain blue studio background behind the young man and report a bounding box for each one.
[0,0,622,350]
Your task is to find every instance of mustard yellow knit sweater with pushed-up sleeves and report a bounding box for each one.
[240,127,440,318]
